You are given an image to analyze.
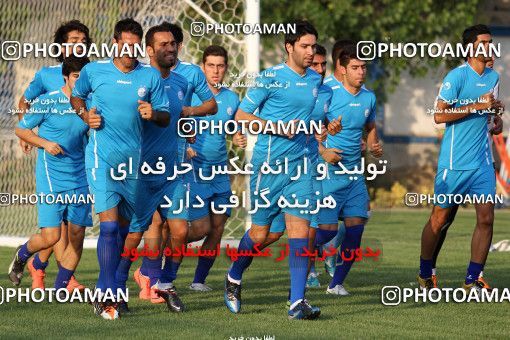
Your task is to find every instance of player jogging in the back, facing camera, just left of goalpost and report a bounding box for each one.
[188,45,239,291]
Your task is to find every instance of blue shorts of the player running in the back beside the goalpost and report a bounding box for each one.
[189,175,232,221]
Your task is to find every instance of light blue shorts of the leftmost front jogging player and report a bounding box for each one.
[37,186,92,228]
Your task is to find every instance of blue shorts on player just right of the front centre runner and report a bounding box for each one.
[319,176,370,224]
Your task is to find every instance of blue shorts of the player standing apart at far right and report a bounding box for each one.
[434,165,496,208]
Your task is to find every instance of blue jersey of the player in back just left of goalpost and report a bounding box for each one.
[191,88,239,180]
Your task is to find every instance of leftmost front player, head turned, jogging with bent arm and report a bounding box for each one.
[9,56,92,298]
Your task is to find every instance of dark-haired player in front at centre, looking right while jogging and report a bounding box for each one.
[224,21,321,319]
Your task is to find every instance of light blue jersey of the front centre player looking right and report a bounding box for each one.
[239,63,321,164]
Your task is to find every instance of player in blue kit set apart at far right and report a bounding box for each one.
[418,25,501,291]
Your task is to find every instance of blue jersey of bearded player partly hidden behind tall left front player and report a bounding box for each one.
[140,71,188,181]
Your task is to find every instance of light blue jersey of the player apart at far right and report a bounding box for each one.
[437,63,499,170]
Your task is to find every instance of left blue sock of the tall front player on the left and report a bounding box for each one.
[96,221,120,292]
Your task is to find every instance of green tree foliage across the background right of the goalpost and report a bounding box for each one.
[260,0,483,101]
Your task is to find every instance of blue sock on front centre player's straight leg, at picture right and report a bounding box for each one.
[289,238,308,304]
